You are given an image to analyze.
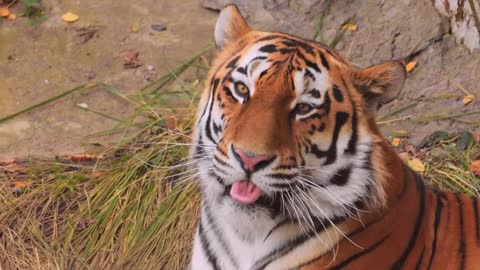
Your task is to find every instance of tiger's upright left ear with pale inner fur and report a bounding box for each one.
[215,5,250,49]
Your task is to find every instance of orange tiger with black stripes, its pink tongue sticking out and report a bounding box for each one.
[188,5,480,270]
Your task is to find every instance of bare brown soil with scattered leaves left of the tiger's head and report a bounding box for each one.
[0,0,216,159]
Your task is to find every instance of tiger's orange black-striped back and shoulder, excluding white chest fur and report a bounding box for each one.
[306,140,480,270]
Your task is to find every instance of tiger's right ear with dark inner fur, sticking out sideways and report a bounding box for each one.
[353,61,407,115]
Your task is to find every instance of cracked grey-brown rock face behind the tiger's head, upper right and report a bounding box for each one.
[201,0,480,146]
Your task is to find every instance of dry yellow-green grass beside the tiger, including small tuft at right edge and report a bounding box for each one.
[0,45,480,270]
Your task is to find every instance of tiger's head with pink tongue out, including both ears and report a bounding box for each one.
[193,5,406,235]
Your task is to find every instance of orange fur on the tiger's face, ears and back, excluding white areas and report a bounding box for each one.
[192,6,480,270]
